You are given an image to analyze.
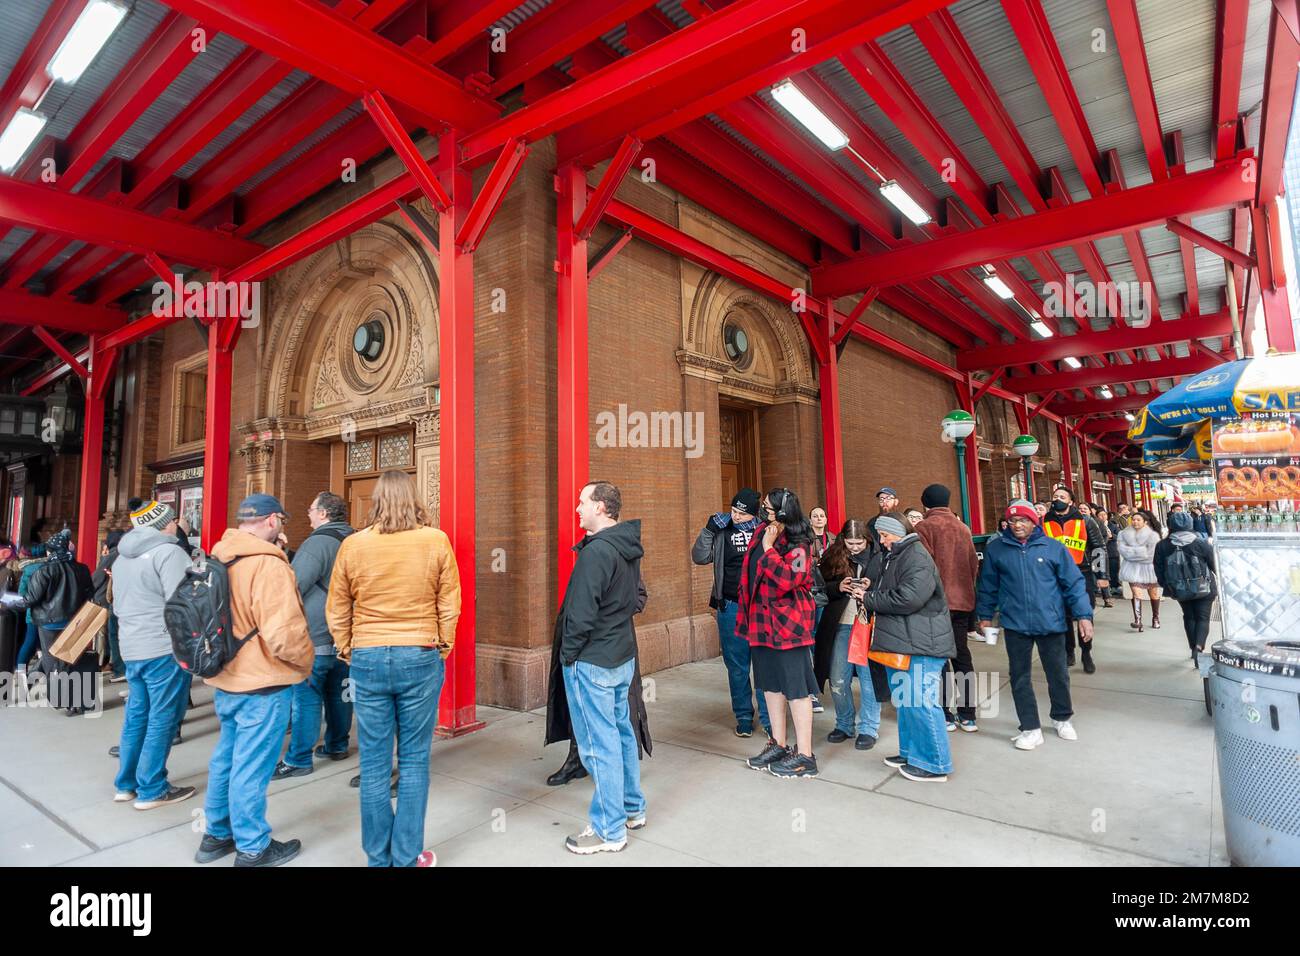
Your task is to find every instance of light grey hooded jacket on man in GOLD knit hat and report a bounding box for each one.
[113,528,190,661]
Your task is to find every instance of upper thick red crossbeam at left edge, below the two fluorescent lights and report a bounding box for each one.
[0,177,261,265]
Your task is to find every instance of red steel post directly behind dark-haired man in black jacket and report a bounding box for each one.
[555,164,590,607]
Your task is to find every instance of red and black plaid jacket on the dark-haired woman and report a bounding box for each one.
[736,524,816,650]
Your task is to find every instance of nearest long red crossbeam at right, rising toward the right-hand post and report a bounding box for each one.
[815,163,1253,295]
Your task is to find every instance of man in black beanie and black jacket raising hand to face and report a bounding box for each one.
[690,488,771,737]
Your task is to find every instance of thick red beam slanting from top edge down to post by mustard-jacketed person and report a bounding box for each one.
[168,0,496,132]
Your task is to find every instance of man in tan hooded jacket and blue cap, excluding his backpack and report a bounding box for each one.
[195,494,316,866]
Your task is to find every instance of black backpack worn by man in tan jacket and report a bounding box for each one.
[163,551,257,678]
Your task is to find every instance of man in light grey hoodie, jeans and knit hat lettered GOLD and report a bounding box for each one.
[112,501,194,810]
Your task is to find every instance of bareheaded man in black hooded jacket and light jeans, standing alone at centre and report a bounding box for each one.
[559,481,646,855]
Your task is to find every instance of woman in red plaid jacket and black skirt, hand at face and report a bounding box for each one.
[736,488,818,778]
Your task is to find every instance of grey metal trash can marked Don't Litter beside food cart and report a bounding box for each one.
[1210,640,1300,866]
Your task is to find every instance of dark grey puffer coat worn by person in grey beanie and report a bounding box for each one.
[862,533,957,658]
